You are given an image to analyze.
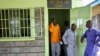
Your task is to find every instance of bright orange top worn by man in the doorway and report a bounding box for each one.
[49,23,61,43]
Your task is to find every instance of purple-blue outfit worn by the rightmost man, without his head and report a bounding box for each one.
[83,28,100,56]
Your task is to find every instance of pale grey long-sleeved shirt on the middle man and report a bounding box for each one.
[62,29,77,46]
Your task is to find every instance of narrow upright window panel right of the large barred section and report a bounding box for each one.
[35,8,44,37]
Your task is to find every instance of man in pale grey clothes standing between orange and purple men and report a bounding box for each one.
[62,23,77,56]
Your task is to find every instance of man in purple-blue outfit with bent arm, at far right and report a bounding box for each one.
[81,20,100,56]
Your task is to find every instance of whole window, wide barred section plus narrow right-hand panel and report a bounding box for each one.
[0,8,44,38]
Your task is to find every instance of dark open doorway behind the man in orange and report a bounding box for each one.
[48,9,70,56]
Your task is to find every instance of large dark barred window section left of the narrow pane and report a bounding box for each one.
[0,9,31,37]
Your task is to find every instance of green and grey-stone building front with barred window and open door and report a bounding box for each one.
[0,0,97,56]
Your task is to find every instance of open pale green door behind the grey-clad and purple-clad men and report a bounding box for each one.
[70,6,90,56]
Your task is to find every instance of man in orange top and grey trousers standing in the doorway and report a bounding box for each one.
[49,18,61,56]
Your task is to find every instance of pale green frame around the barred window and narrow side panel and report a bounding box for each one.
[0,7,44,41]
